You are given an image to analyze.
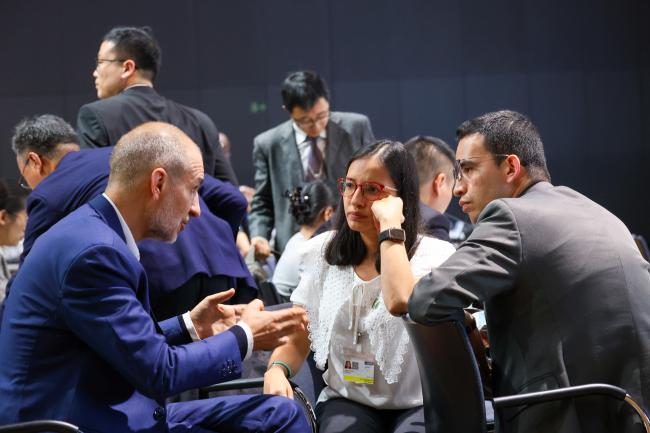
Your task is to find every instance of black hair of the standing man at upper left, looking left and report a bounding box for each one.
[102,26,162,82]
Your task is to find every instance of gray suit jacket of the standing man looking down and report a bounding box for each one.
[250,112,375,252]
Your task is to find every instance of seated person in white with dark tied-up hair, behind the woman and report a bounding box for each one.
[273,180,336,298]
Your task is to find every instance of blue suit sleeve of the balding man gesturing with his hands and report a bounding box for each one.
[60,245,241,400]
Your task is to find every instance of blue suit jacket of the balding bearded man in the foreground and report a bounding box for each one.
[0,196,241,433]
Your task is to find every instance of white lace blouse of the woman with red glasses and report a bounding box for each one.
[291,232,455,409]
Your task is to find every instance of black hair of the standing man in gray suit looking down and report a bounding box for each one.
[281,71,330,113]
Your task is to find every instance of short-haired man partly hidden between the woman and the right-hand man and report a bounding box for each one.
[404,135,454,242]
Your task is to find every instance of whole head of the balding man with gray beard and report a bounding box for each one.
[106,122,204,242]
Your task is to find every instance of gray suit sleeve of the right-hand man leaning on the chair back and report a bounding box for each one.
[408,200,522,324]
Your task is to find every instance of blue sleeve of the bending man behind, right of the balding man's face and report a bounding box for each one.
[199,175,248,235]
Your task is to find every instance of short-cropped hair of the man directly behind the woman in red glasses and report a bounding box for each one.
[404,135,456,183]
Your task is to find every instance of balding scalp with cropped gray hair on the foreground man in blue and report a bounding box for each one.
[108,122,201,190]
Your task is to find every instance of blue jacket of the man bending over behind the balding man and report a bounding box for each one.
[12,147,256,304]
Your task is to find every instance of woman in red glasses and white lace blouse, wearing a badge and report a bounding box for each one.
[264,141,454,433]
